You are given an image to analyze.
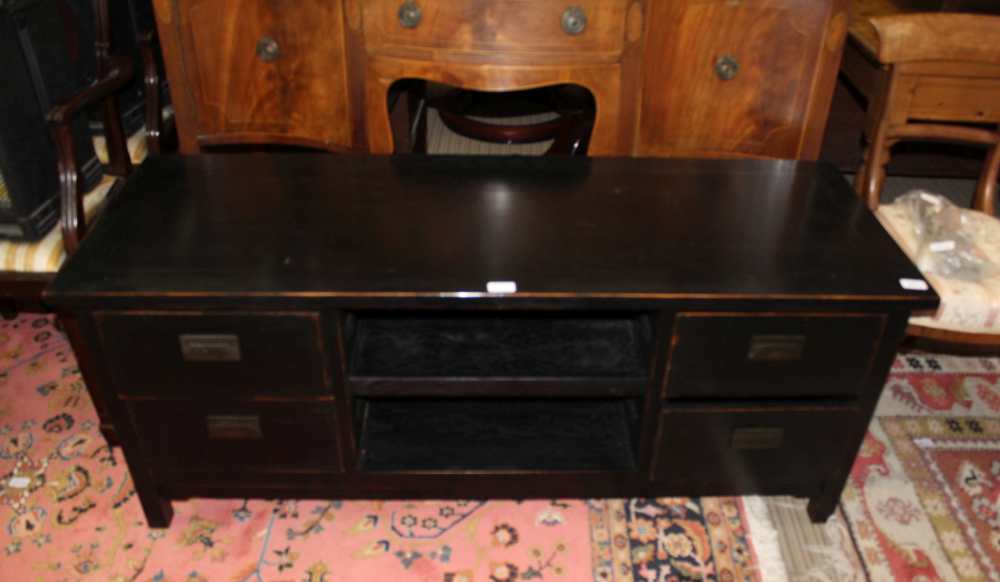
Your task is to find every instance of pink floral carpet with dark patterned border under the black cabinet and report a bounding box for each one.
[0,315,772,582]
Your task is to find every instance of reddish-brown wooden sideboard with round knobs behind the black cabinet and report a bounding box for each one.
[155,0,848,159]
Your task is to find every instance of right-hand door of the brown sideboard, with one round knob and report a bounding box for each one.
[636,0,846,158]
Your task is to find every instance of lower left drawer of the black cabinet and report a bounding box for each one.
[128,401,343,475]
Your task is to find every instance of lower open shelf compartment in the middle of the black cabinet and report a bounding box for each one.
[355,398,641,472]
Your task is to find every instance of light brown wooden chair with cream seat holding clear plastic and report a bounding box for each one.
[852,13,1000,351]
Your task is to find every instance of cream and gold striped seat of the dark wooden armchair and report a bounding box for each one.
[0,130,146,273]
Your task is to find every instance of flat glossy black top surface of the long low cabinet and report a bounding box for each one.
[47,154,936,307]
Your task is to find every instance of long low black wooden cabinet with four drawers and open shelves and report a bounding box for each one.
[46,154,938,526]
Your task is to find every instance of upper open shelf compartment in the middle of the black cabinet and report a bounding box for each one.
[347,311,653,395]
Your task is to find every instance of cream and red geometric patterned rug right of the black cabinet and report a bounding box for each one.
[842,355,1000,582]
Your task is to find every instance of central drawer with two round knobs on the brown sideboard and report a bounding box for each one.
[364,0,628,53]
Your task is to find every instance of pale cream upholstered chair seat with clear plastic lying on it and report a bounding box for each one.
[875,204,1000,334]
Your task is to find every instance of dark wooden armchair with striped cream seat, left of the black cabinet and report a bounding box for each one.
[0,0,158,315]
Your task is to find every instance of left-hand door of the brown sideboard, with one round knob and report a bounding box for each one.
[178,0,351,147]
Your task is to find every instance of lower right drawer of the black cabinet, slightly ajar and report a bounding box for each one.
[650,408,857,495]
